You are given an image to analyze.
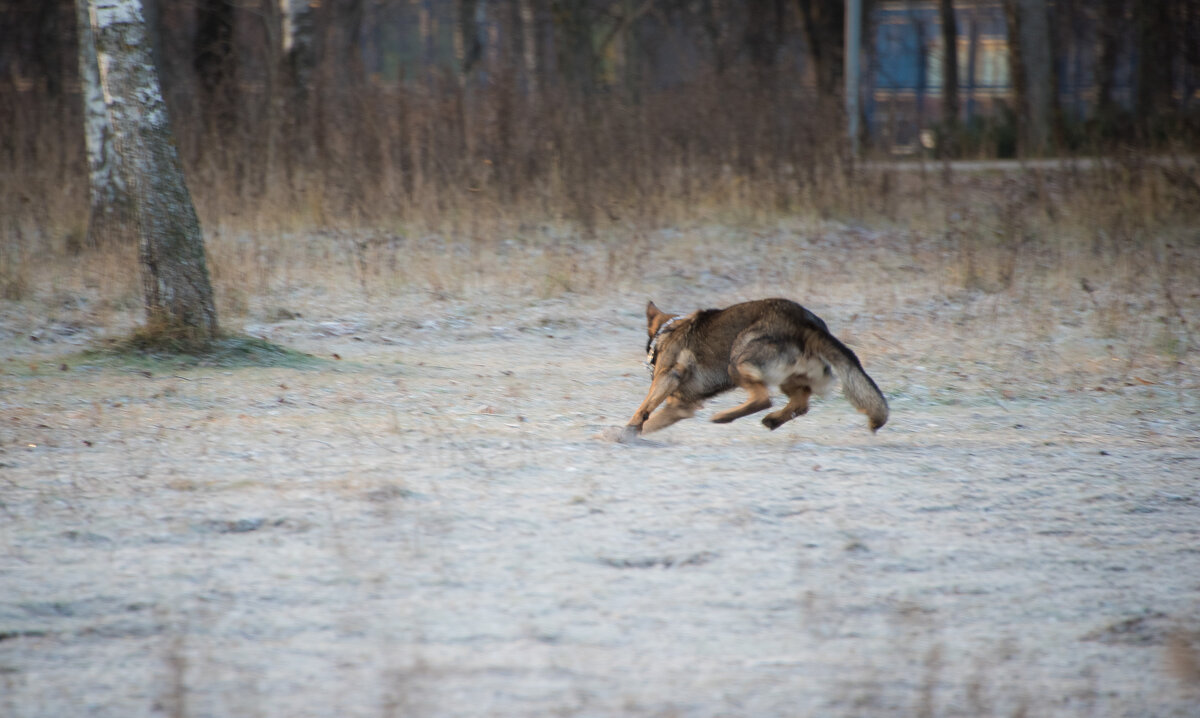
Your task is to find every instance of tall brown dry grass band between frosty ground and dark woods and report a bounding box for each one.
[0,72,1200,354]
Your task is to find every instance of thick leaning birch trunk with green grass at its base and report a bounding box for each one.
[89,0,217,345]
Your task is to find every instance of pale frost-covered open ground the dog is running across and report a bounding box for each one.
[0,226,1200,718]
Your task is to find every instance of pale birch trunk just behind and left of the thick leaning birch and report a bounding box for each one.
[76,0,133,249]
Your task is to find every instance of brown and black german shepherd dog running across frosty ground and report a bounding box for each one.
[620,299,888,441]
